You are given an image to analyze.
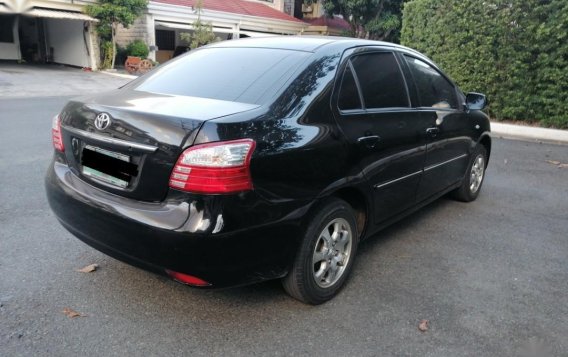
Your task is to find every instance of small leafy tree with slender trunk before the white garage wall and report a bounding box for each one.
[85,0,148,68]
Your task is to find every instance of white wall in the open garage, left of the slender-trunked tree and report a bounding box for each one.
[45,19,91,67]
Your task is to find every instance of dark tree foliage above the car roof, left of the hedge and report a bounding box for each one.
[307,0,403,42]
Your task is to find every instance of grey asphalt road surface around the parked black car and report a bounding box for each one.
[0,98,568,356]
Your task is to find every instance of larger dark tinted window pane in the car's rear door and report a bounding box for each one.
[351,52,409,109]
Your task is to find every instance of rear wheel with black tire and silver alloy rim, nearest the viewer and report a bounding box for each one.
[282,198,359,305]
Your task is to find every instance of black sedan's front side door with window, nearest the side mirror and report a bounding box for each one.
[403,55,472,201]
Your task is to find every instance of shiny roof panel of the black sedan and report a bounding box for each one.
[207,36,423,56]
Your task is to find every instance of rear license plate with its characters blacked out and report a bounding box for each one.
[81,145,138,188]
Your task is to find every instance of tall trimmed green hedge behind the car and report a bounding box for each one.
[401,0,568,128]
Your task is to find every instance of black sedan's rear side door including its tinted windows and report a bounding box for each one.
[332,48,428,223]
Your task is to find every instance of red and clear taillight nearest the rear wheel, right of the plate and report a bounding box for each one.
[166,139,255,194]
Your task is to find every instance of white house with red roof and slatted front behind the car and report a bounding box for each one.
[117,0,309,63]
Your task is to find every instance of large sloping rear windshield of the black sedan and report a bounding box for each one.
[136,48,311,104]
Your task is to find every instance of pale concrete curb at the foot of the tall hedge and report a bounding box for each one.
[491,122,568,144]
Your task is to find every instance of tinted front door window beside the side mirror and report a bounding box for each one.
[405,56,458,109]
